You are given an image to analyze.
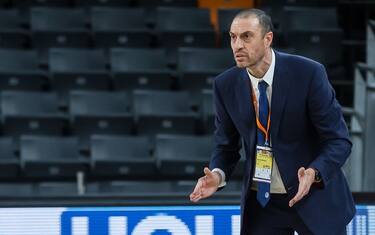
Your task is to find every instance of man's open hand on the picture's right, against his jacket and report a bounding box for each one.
[289,167,315,207]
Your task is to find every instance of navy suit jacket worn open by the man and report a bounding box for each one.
[210,51,355,235]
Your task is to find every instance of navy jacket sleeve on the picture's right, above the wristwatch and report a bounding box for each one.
[307,65,352,185]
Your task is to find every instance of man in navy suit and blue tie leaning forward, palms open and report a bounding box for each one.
[190,9,355,235]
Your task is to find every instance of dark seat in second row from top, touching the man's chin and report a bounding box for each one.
[178,48,234,92]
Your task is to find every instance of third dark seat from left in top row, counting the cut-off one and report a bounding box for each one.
[90,7,152,48]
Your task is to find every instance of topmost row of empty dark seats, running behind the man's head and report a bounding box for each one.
[0,7,342,51]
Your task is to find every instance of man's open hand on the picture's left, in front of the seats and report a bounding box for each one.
[190,167,221,202]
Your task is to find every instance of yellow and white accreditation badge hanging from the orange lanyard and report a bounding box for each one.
[253,146,272,183]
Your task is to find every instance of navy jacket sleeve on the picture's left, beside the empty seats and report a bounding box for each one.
[210,79,241,181]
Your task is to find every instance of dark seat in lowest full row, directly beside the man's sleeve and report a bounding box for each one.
[155,135,213,178]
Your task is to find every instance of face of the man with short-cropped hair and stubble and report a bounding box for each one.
[229,16,272,68]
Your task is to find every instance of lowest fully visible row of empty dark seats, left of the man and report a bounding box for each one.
[0,134,244,179]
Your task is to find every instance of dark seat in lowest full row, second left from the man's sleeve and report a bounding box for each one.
[91,135,156,176]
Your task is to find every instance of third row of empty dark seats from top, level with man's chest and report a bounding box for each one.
[0,90,213,138]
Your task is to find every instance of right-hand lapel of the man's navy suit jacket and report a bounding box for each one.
[271,51,290,142]
